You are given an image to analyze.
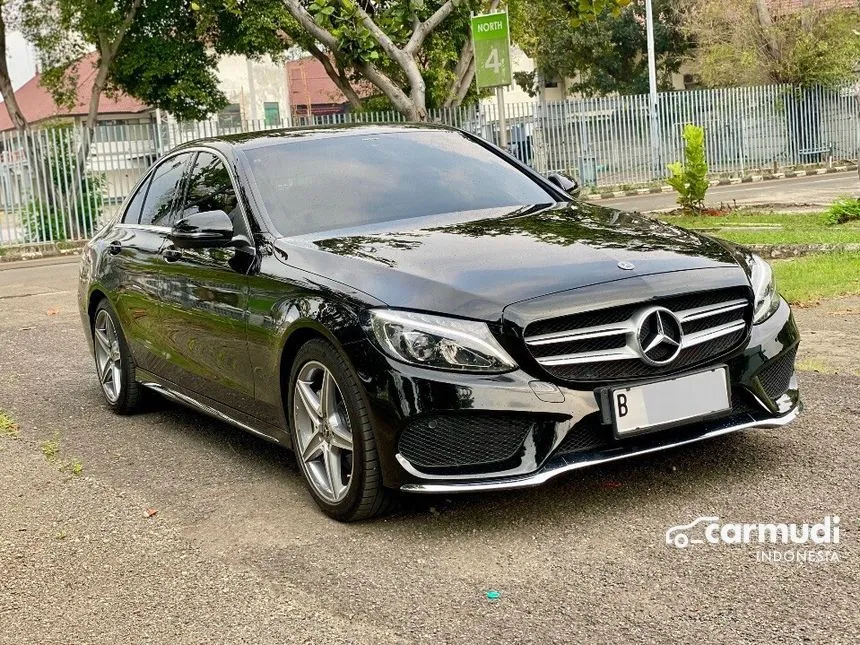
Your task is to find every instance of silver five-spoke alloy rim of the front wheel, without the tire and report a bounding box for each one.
[293,361,353,503]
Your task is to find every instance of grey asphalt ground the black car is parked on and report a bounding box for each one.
[0,264,860,645]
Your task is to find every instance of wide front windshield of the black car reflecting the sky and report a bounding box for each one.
[246,130,555,235]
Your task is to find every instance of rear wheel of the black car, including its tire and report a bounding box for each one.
[91,299,142,414]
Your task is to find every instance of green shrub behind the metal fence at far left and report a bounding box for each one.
[23,126,105,243]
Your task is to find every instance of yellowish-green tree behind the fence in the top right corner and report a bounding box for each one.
[686,0,860,87]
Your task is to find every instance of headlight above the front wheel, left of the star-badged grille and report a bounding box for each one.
[370,309,516,372]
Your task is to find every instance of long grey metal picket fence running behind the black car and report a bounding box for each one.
[0,86,860,246]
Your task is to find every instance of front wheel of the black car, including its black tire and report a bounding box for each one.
[287,339,397,522]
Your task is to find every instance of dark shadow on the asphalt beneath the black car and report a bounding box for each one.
[127,384,780,534]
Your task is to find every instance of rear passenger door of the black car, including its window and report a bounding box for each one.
[105,153,191,373]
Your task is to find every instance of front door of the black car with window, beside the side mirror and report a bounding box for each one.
[155,151,254,412]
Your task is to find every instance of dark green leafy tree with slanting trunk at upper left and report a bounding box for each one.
[23,0,226,140]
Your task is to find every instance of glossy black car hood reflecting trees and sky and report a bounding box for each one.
[276,202,741,320]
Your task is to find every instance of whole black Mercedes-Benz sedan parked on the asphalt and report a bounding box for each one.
[80,124,800,520]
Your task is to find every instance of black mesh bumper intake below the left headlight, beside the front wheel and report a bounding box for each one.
[398,413,535,468]
